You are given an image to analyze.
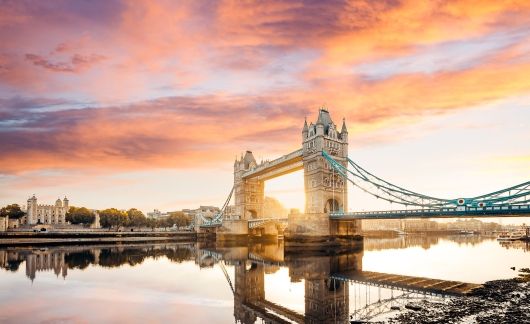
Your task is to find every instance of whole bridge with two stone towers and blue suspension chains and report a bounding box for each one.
[195,108,530,244]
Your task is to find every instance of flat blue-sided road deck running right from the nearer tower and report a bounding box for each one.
[329,205,530,220]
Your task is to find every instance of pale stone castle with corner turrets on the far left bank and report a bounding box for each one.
[22,195,69,225]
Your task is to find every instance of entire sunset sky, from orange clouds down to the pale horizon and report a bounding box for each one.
[0,0,530,221]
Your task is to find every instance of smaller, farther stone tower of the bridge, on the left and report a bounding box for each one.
[234,151,265,220]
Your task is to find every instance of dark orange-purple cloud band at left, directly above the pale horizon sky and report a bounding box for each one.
[0,96,307,173]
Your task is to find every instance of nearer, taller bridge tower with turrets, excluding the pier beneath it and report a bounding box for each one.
[302,108,348,214]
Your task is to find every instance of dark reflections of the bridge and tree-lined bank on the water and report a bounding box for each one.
[0,240,490,323]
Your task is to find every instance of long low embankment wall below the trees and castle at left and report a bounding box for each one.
[0,231,197,246]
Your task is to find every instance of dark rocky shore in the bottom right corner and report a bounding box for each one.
[387,268,530,323]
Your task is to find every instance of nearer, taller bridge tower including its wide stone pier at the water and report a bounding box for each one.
[285,108,362,249]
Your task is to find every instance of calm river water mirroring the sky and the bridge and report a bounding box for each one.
[0,235,530,323]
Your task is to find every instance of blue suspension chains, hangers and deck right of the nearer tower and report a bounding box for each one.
[322,151,530,218]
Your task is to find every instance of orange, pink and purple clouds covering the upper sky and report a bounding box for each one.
[0,0,530,177]
